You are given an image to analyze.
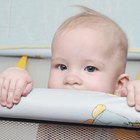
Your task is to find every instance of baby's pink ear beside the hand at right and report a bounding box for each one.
[115,74,130,96]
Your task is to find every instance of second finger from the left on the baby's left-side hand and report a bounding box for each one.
[6,80,16,108]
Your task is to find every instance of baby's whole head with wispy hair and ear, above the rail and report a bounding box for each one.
[48,7,128,93]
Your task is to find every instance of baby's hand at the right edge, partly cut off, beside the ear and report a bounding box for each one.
[121,80,140,112]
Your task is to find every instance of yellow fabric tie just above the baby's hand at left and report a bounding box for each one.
[16,55,27,69]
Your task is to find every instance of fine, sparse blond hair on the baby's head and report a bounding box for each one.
[52,6,128,73]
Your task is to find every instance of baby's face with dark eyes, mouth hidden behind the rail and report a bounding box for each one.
[48,28,118,93]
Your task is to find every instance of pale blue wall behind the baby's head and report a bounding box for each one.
[0,0,140,48]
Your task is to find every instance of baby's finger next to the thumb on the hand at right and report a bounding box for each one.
[127,85,135,107]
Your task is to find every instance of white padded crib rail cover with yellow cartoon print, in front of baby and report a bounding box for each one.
[0,88,140,129]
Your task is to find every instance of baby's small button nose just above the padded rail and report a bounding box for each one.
[64,75,82,85]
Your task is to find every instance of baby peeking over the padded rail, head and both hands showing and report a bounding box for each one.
[0,7,140,111]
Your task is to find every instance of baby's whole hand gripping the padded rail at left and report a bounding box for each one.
[0,67,32,108]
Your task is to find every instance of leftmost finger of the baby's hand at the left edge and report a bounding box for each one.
[0,79,10,106]
